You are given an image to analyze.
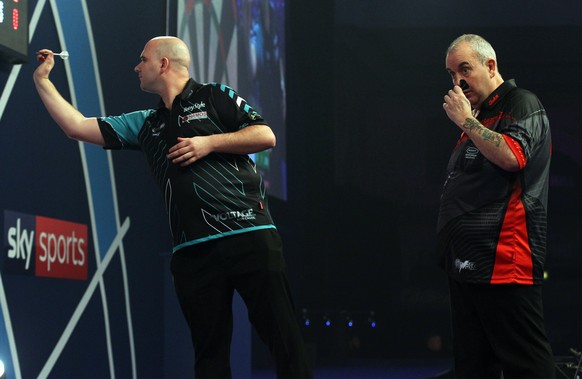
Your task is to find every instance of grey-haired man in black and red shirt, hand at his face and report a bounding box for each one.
[437,34,555,379]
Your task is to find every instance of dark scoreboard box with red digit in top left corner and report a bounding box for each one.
[0,0,28,63]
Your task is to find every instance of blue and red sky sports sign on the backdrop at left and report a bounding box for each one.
[0,210,89,280]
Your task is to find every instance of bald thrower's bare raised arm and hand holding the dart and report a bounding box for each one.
[33,49,105,146]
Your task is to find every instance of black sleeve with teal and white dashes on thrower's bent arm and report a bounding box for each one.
[212,83,267,132]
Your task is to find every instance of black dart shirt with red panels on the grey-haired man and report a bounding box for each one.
[437,80,551,284]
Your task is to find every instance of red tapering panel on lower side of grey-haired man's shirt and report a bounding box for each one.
[491,181,533,284]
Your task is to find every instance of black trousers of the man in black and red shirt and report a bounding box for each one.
[449,279,556,379]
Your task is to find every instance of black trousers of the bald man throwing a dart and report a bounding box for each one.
[171,229,312,379]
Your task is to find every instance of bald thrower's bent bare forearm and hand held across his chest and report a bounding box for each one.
[168,125,276,166]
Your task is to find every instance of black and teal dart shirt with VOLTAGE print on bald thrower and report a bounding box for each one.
[98,79,275,251]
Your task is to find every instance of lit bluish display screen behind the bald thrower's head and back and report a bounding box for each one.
[177,0,287,200]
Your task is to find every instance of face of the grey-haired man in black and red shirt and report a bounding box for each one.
[446,42,497,109]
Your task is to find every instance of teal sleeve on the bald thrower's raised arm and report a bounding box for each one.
[97,110,154,149]
